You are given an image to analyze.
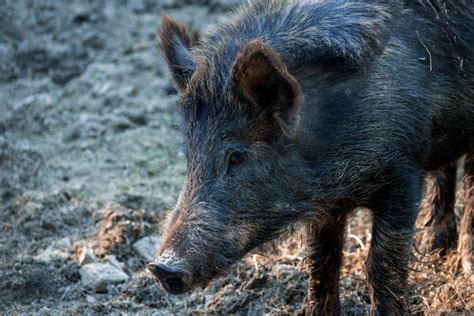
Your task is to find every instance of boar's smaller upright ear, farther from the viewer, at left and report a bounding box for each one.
[158,16,196,90]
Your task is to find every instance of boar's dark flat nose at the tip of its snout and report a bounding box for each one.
[147,262,187,295]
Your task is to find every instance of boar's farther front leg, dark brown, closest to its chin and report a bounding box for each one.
[304,212,347,315]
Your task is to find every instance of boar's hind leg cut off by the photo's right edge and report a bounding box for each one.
[458,150,474,275]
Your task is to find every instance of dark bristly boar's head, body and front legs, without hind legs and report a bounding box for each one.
[149,0,474,314]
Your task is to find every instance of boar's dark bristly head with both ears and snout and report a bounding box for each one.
[148,17,312,294]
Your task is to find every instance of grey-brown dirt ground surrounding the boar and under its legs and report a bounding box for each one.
[0,0,474,315]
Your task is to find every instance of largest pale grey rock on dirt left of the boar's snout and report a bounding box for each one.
[79,263,128,293]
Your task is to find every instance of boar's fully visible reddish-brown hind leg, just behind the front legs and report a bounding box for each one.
[419,163,456,254]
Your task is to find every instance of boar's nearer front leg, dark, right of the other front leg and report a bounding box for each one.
[366,177,423,315]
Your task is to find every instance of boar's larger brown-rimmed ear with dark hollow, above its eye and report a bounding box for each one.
[232,39,302,136]
